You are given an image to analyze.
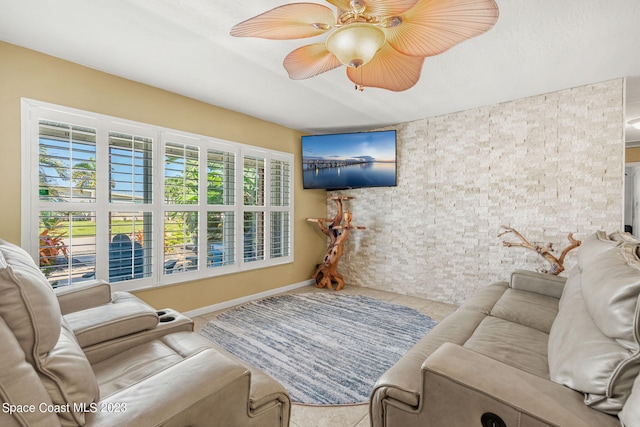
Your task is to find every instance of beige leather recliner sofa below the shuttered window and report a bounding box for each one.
[0,240,290,427]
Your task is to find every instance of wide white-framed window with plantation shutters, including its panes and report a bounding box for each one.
[22,100,293,290]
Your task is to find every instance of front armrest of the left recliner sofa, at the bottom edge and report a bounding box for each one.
[86,349,250,427]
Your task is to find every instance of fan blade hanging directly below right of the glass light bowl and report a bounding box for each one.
[347,43,424,92]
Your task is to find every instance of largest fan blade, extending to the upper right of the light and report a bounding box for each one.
[385,0,498,56]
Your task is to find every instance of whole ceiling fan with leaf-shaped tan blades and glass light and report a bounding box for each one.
[231,0,498,92]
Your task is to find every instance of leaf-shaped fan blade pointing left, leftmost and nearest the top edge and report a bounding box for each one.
[231,3,336,40]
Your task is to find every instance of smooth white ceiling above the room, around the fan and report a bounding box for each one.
[0,0,640,140]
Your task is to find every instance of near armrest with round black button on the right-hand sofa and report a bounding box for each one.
[421,343,620,427]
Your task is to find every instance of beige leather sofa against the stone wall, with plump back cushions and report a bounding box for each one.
[370,232,640,427]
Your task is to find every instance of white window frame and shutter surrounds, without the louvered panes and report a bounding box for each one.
[21,98,294,291]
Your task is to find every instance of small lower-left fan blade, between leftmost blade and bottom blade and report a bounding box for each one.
[283,43,342,80]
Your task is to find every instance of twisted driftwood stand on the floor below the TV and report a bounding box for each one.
[307,196,365,291]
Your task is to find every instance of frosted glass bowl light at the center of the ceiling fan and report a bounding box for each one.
[326,22,386,68]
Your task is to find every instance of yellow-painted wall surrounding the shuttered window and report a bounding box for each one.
[0,42,326,311]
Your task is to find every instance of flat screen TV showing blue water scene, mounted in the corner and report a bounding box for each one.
[302,130,396,190]
